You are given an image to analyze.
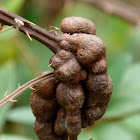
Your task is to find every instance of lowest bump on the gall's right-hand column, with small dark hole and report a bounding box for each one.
[85,107,106,125]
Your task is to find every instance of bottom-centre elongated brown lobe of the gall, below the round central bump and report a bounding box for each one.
[66,109,81,136]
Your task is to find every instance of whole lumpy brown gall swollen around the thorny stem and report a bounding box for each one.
[30,17,113,140]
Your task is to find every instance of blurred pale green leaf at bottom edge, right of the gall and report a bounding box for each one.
[93,123,138,140]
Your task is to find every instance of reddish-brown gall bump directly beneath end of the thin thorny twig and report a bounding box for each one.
[33,78,57,99]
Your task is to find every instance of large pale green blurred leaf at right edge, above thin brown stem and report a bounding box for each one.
[105,63,140,117]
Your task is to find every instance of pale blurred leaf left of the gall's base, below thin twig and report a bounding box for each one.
[7,106,35,125]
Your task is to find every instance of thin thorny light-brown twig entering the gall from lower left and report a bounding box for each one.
[0,71,53,107]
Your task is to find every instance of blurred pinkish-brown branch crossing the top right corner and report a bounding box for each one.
[79,0,140,27]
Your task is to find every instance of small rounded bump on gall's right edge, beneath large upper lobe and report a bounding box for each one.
[88,56,108,74]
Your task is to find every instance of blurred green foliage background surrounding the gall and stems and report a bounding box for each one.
[0,0,140,140]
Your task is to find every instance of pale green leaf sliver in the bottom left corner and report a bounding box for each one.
[0,134,31,140]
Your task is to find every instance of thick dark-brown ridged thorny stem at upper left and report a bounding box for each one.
[0,7,61,53]
